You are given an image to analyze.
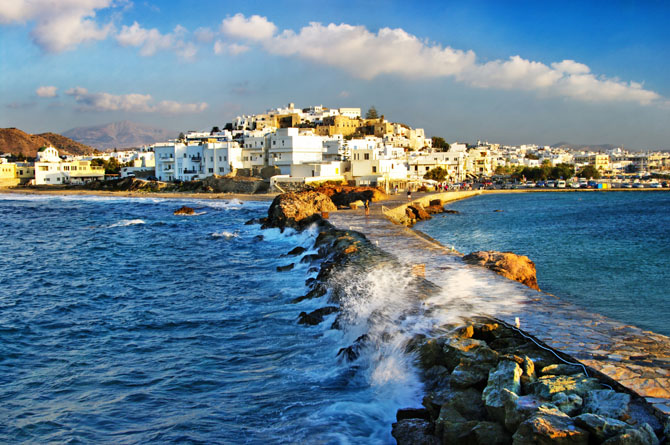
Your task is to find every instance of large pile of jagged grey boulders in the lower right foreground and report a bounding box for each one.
[393,318,670,445]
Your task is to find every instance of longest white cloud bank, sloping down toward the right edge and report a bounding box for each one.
[220,14,665,105]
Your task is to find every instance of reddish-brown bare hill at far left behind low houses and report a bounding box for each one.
[0,128,93,157]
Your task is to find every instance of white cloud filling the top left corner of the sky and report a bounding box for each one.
[0,0,114,53]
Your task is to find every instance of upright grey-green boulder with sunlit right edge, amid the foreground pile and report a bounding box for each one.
[482,360,523,423]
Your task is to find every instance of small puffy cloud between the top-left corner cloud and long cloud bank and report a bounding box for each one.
[116,22,198,60]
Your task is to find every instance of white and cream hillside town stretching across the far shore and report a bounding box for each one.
[0,103,670,191]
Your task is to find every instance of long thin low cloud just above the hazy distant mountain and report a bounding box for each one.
[65,87,207,114]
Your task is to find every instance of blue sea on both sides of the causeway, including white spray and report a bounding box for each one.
[0,192,670,444]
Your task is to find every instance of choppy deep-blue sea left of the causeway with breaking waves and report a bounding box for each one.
[0,195,430,444]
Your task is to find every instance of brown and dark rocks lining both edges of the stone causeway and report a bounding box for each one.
[261,191,670,444]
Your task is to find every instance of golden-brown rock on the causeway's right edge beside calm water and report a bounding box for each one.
[463,251,540,291]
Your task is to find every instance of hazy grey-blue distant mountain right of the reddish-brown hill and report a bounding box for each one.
[63,121,177,150]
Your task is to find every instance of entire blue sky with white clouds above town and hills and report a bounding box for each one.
[0,0,670,150]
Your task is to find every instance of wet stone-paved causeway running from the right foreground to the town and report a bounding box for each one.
[330,192,670,416]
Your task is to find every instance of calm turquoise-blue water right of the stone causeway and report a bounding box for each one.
[416,192,670,335]
